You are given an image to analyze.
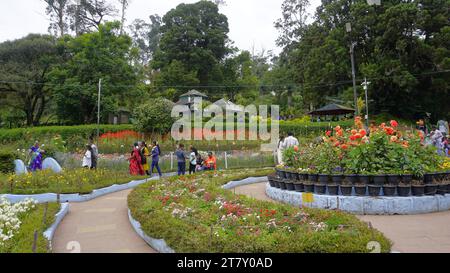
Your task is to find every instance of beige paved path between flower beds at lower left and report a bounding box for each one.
[53,190,156,253]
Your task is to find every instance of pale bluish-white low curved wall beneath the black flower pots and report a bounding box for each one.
[266,183,450,215]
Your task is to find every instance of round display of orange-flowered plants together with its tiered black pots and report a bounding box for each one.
[277,117,450,196]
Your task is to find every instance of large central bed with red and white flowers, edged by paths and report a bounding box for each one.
[128,170,391,253]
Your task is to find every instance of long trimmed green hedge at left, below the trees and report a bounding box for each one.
[0,124,133,144]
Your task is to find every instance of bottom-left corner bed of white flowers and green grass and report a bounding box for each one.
[0,199,59,253]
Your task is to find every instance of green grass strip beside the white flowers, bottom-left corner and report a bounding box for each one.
[0,204,60,253]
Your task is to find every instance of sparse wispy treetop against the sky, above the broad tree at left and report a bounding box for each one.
[68,0,117,35]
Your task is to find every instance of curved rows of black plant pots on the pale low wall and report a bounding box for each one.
[269,174,450,197]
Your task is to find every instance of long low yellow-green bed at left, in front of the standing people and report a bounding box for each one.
[0,168,145,194]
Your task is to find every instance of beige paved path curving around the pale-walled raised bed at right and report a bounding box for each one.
[234,183,450,253]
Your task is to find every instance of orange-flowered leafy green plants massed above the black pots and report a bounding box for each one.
[284,117,444,177]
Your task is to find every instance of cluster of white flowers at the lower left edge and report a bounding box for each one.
[0,198,35,247]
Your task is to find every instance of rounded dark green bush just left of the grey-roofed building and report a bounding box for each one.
[133,98,174,134]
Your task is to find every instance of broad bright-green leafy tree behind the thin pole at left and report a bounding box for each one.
[50,22,139,124]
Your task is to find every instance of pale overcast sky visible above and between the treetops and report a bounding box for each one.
[0,0,320,53]
